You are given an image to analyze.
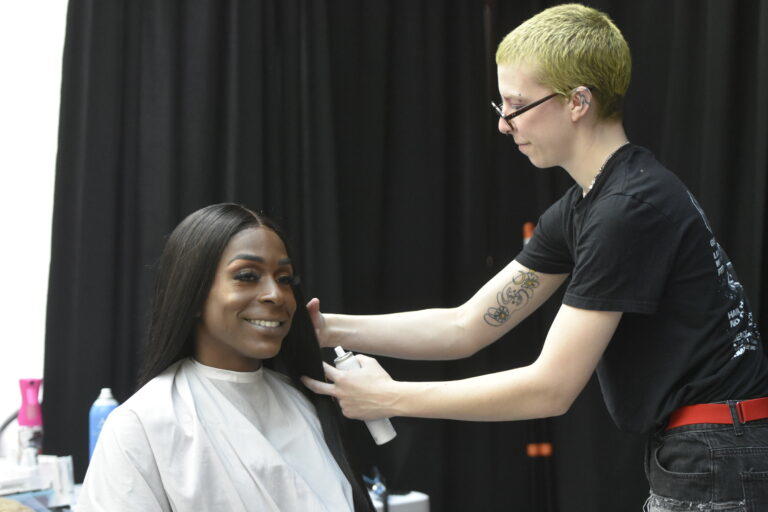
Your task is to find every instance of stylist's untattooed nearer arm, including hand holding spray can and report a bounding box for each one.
[302,305,621,421]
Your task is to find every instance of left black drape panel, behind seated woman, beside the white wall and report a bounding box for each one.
[44,0,342,477]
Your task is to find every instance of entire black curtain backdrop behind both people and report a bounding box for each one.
[43,0,768,512]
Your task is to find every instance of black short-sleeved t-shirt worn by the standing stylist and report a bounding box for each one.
[516,145,768,432]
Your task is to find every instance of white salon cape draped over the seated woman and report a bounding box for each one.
[76,359,354,512]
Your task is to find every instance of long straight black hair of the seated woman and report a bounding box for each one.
[139,203,374,512]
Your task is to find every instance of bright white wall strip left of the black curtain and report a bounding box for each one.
[0,0,67,454]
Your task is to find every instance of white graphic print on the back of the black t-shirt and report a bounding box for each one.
[688,192,760,357]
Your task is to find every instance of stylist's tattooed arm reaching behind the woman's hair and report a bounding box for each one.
[307,261,568,360]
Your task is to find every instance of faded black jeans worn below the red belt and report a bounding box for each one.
[645,412,768,512]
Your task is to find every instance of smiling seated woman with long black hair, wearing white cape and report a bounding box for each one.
[78,204,373,512]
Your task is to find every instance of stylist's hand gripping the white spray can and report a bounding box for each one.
[301,355,399,420]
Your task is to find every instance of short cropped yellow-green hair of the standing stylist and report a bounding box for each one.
[496,4,632,119]
